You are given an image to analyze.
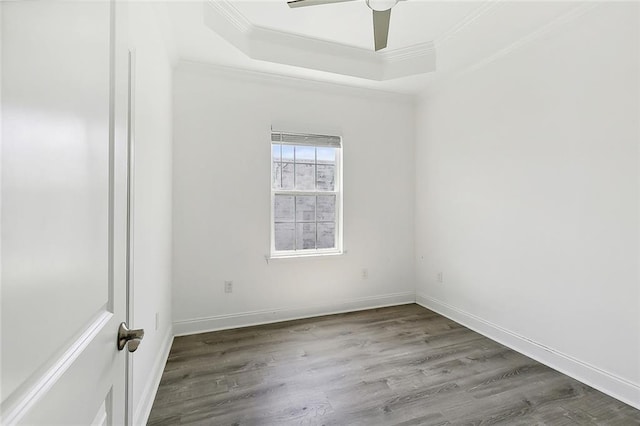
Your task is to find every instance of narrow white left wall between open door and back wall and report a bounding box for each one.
[128,2,173,424]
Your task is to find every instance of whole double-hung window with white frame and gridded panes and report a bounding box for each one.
[271,131,342,257]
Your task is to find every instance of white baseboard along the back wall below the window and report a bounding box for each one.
[173,292,415,336]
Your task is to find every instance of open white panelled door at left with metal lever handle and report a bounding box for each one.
[0,0,135,425]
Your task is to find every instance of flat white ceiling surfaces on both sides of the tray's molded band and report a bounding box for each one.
[158,0,594,94]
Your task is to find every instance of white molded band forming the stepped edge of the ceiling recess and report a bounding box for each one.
[203,0,436,81]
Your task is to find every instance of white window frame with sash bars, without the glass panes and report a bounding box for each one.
[269,130,344,259]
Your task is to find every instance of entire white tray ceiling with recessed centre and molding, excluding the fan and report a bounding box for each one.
[157,0,598,94]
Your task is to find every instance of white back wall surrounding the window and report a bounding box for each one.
[173,63,415,334]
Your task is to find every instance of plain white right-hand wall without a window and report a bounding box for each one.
[415,3,640,407]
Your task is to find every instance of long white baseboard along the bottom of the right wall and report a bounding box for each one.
[416,293,640,409]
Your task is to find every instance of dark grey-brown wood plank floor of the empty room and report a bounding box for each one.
[148,305,640,426]
